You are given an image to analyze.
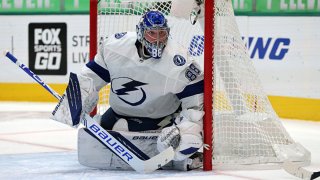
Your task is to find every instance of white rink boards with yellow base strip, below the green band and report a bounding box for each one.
[0,15,320,120]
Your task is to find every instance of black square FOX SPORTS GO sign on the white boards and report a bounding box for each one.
[29,23,67,75]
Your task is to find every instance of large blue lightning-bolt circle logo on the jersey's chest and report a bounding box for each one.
[111,77,147,106]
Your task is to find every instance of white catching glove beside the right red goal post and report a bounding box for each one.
[157,109,204,161]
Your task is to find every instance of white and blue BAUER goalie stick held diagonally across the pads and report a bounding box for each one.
[4,51,174,173]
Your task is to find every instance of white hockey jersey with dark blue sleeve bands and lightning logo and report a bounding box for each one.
[82,32,203,118]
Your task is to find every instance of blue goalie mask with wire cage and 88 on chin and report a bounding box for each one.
[137,10,170,59]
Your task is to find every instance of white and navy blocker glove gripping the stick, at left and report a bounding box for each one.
[50,73,99,128]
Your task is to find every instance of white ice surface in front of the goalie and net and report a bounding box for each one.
[0,102,320,180]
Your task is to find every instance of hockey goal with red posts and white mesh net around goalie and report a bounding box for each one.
[90,0,310,170]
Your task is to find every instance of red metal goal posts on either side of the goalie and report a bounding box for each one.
[89,0,221,171]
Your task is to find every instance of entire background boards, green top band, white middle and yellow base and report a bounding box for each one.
[0,0,320,121]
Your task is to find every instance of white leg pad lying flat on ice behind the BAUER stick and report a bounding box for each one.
[78,128,159,170]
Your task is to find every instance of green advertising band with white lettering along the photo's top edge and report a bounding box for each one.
[0,0,320,16]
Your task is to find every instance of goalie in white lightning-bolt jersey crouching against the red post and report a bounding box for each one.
[52,10,204,170]
